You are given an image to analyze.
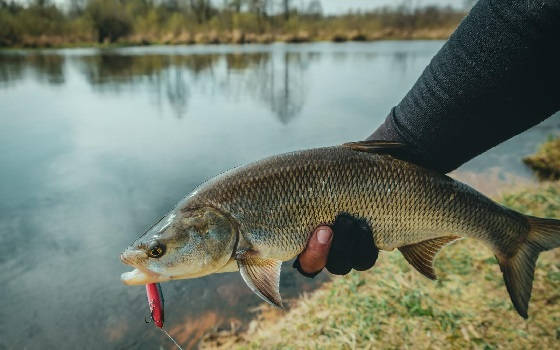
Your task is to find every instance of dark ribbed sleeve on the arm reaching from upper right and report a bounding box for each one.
[369,0,560,172]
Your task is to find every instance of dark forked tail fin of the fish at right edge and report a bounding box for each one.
[496,216,560,318]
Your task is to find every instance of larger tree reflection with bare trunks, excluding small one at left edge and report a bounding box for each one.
[82,52,313,124]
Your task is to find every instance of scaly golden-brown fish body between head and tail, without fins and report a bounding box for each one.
[186,147,527,257]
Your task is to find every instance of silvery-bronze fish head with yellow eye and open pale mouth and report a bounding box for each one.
[121,207,237,285]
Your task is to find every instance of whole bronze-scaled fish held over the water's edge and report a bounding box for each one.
[121,140,560,318]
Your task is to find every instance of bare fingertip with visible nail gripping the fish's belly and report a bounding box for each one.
[298,226,333,273]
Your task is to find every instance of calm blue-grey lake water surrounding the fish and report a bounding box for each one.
[0,41,560,349]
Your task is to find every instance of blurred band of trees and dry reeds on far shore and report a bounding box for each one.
[0,0,464,47]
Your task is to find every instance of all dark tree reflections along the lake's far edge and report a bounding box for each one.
[0,52,316,124]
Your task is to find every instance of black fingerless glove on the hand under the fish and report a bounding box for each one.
[293,213,379,278]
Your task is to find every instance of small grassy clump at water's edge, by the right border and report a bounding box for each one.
[523,138,560,180]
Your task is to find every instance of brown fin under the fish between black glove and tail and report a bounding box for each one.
[399,236,461,280]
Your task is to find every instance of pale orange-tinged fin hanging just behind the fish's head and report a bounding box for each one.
[236,252,284,308]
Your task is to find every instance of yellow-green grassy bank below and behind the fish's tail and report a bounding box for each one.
[201,183,560,349]
